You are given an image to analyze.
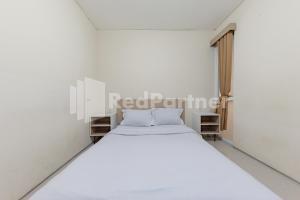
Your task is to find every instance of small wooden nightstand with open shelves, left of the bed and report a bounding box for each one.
[90,114,116,144]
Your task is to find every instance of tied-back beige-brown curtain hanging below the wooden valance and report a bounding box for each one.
[217,31,233,131]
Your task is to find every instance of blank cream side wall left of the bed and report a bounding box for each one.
[0,0,97,200]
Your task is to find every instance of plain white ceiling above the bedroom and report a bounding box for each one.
[76,0,243,30]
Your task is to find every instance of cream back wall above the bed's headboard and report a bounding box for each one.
[98,30,214,124]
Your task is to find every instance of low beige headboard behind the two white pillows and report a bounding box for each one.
[116,99,185,124]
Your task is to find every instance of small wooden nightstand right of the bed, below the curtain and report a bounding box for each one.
[192,112,221,141]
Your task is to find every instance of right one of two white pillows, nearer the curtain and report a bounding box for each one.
[152,108,184,125]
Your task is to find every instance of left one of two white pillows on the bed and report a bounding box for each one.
[121,109,152,126]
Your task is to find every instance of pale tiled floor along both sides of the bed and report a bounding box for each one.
[22,141,300,200]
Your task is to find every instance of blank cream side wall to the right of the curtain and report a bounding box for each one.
[217,0,300,181]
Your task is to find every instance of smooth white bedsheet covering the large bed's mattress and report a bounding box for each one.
[31,126,280,200]
